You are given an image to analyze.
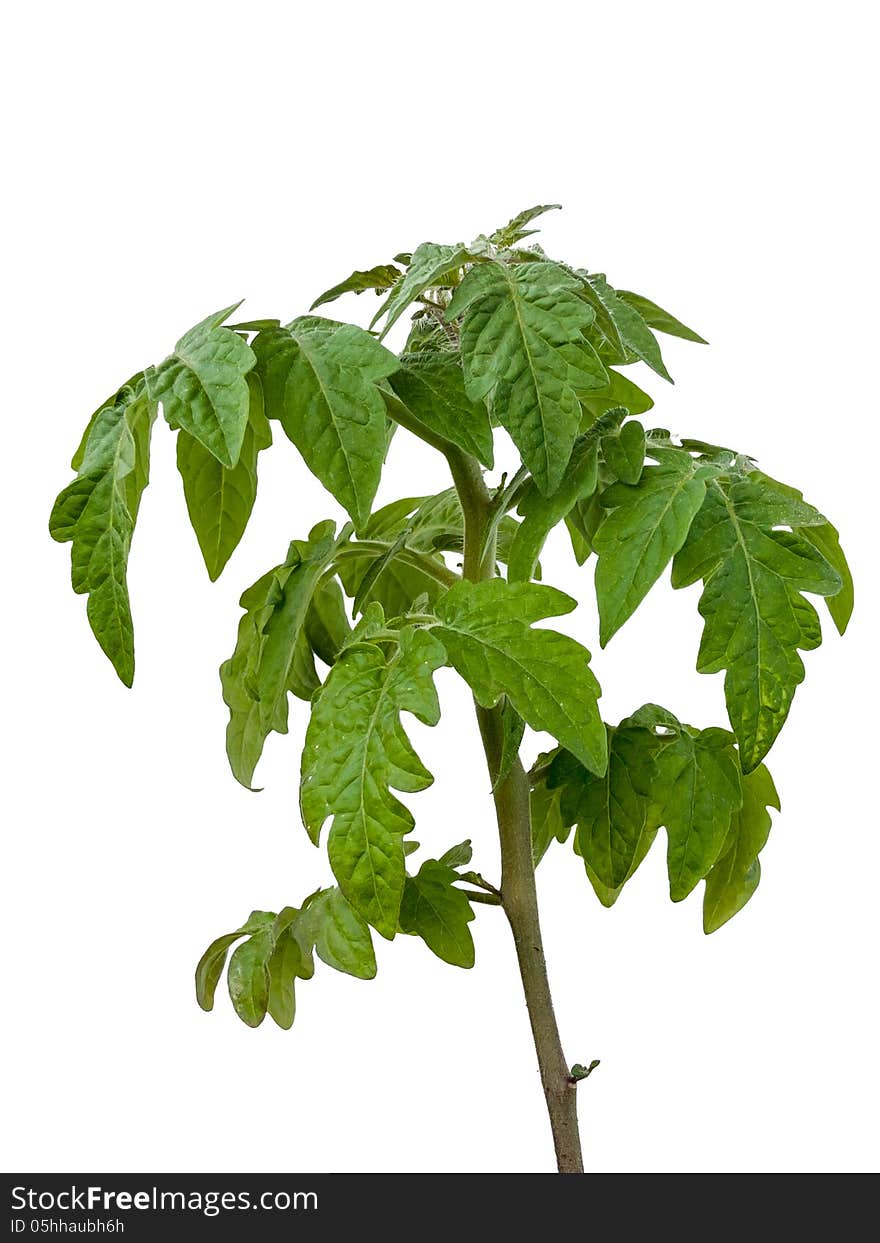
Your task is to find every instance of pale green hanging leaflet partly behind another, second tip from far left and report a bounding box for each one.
[178,373,272,582]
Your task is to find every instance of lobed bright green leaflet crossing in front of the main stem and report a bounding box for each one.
[434,578,608,772]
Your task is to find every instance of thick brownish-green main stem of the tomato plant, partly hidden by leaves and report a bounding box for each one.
[446,451,584,1173]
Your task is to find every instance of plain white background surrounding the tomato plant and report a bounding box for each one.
[0,0,880,1172]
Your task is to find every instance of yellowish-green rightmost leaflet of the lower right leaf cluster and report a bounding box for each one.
[702,764,779,933]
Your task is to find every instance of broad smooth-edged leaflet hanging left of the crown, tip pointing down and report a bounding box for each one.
[254,316,399,527]
